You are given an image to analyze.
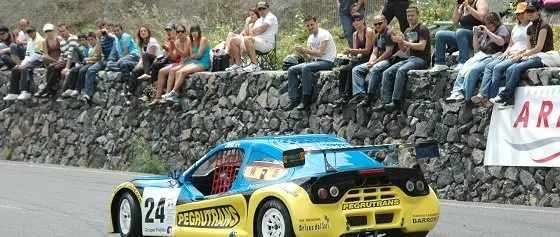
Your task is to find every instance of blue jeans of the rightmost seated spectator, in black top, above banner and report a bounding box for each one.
[500,57,544,104]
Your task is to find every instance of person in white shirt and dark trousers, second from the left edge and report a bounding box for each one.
[4,26,44,100]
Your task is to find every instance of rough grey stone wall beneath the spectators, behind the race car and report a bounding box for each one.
[0,68,560,207]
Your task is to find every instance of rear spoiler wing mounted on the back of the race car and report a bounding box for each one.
[282,140,440,169]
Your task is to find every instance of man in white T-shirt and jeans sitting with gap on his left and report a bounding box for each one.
[284,17,336,110]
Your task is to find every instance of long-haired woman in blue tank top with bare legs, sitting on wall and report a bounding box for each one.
[165,25,212,103]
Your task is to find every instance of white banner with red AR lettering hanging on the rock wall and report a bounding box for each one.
[484,86,560,167]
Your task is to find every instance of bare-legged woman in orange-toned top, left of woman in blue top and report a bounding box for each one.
[150,25,191,105]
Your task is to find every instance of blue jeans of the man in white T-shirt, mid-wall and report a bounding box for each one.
[288,60,334,101]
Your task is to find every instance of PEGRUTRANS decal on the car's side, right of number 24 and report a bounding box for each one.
[177,205,240,228]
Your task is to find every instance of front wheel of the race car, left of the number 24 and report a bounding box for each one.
[117,192,142,237]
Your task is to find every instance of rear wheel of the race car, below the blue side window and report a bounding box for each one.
[256,199,295,237]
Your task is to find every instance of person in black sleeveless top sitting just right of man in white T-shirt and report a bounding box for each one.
[335,12,375,105]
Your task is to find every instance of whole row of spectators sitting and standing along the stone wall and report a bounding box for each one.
[0,0,554,111]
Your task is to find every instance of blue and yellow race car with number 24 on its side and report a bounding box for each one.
[109,135,440,237]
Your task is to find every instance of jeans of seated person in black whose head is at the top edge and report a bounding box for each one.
[435,28,473,64]
